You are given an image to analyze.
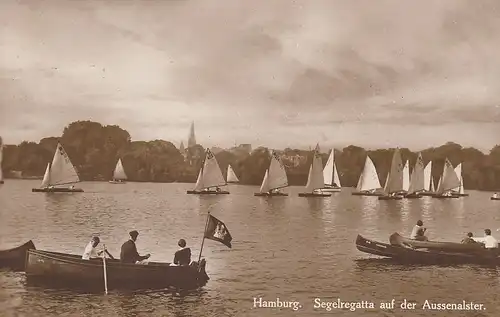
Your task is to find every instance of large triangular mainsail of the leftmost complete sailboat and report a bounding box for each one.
[50,143,80,186]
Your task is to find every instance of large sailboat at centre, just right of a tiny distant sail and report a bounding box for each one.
[254,151,288,197]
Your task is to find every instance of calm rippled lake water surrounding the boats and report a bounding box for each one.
[0,180,500,316]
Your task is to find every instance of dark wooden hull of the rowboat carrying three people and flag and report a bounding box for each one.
[26,250,209,290]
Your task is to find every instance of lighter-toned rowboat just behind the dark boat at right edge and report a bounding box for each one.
[389,232,483,252]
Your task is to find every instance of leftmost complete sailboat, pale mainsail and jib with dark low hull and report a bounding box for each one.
[31,143,83,193]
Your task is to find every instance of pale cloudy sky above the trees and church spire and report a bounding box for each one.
[0,0,500,151]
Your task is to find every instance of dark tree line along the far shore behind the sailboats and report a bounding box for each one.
[2,121,500,190]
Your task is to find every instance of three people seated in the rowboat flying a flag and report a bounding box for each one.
[82,230,192,265]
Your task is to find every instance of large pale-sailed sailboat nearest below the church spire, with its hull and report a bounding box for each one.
[187,149,229,195]
